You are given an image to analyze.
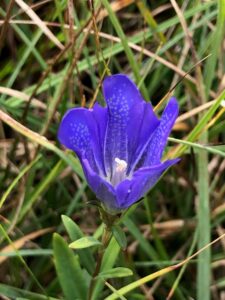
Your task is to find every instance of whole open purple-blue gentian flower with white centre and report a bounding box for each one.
[58,74,179,214]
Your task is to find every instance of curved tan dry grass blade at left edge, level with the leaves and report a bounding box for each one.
[0,228,54,264]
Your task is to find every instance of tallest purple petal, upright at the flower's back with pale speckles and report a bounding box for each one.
[103,74,157,174]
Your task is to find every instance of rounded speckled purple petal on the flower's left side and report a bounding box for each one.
[58,105,107,175]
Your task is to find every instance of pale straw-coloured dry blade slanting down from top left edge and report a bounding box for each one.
[15,0,64,50]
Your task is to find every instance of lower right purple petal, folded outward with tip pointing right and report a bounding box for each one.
[116,159,179,209]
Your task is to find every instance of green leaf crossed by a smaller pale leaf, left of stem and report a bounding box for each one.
[62,215,95,274]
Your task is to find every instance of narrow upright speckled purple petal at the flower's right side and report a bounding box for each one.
[141,97,179,167]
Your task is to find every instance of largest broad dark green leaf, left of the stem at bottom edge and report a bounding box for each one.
[53,233,87,300]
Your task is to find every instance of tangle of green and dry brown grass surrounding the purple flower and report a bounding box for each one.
[0,0,225,300]
